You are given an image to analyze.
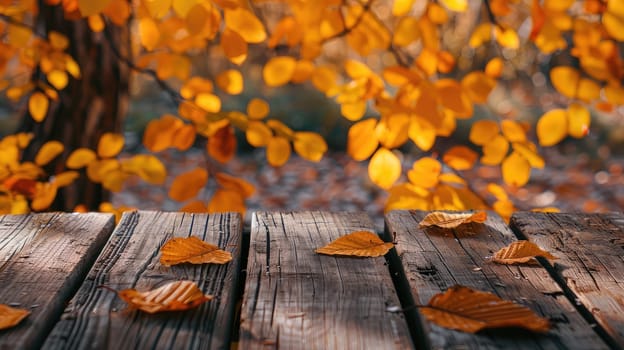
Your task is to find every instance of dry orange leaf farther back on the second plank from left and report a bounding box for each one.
[160,236,232,266]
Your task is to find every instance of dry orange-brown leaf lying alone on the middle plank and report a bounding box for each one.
[316,231,394,257]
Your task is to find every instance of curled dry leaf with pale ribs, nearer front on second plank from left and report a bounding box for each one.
[112,281,212,314]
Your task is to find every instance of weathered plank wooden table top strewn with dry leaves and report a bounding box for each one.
[0,211,624,349]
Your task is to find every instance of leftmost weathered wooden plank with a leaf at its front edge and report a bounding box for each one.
[0,213,115,349]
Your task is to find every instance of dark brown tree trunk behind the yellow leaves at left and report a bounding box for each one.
[20,1,129,211]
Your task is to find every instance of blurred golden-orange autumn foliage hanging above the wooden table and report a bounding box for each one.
[0,0,624,217]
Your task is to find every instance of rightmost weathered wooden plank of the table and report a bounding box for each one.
[511,212,624,348]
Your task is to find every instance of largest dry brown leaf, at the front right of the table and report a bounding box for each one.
[420,286,550,333]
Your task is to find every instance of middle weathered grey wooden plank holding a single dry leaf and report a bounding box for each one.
[240,212,412,349]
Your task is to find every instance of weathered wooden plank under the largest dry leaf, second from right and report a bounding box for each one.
[386,211,607,349]
